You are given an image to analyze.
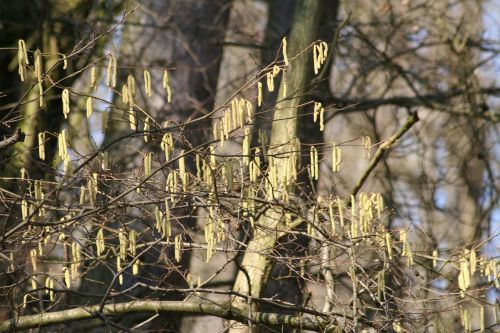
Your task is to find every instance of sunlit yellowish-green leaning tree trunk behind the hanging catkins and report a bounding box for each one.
[230,0,322,332]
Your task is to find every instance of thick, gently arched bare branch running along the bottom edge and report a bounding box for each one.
[0,300,335,332]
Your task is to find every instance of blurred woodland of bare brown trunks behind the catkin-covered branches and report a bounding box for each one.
[0,0,500,332]
